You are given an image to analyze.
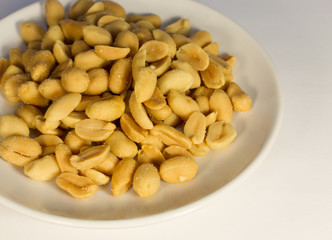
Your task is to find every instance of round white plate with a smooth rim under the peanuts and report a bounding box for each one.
[0,0,282,228]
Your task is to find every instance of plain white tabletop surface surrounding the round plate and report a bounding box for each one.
[0,0,332,240]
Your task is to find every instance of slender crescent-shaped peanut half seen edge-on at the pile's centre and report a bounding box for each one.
[129,92,153,129]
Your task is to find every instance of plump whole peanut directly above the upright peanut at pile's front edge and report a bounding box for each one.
[105,130,138,158]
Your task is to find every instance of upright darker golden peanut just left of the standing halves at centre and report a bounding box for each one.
[108,58,132,94]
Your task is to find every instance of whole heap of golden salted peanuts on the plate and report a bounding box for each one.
[0,0,251,199]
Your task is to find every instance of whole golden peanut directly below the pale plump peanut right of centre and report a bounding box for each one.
[167,90,200,120]
